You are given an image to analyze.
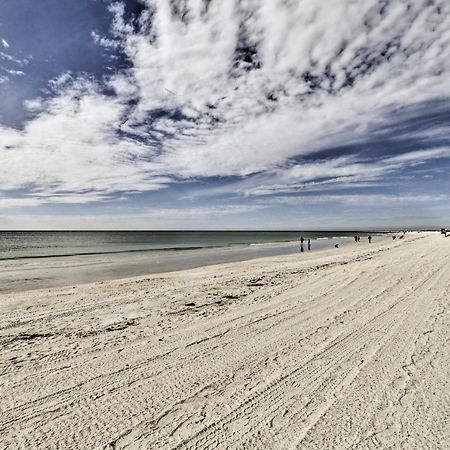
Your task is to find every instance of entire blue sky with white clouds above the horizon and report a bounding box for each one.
[0,0,450,230]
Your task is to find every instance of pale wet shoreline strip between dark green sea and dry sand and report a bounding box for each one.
[0,235,374,294]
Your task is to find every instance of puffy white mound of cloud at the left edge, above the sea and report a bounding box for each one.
[0,80,170,202]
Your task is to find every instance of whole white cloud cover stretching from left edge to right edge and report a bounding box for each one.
[0,0,450,207]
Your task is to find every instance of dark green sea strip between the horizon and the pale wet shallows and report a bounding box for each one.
[0,231,365,260]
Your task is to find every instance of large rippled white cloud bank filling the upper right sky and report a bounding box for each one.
[116,0,450,176]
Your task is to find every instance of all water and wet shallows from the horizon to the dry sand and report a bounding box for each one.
[0,231,372,293]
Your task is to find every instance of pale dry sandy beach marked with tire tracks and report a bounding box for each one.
[0,233,450,450]
